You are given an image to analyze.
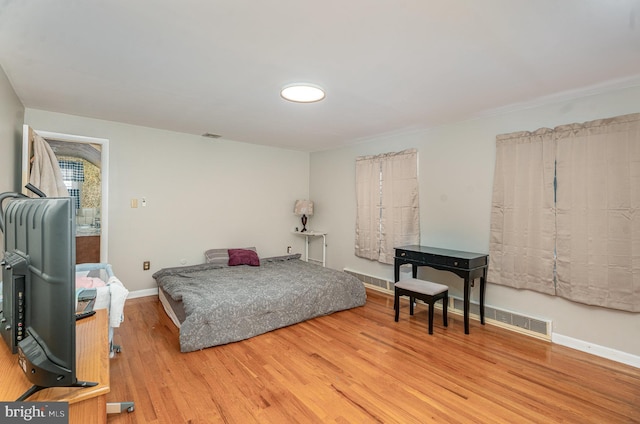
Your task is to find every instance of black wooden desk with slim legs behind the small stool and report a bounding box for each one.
[394,245,489,334]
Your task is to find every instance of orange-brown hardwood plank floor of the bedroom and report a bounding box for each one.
[108,291,640,424]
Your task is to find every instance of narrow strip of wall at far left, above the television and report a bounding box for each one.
[0,67,24,246]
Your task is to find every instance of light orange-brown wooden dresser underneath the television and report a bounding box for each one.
[0,309,110,424]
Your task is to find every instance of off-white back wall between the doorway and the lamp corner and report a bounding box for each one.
[25,109,309,291]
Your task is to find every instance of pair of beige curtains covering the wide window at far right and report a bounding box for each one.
[488,114,640,312]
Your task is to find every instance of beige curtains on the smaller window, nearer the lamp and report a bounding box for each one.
[355,149,420,264]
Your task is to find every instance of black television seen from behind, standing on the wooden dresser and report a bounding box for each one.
[2,197,95,400]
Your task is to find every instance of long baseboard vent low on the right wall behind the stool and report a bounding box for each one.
[344,269,552,340]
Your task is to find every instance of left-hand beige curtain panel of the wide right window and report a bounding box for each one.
[487,128,555,294]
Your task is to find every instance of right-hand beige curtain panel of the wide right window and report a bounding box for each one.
[555,114,640,312]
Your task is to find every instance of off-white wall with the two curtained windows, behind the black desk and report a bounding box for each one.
[310,87,640,362]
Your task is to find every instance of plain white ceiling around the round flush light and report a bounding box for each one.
[0,0,640,151]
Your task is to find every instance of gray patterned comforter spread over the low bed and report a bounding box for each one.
[153,255,366,352]
